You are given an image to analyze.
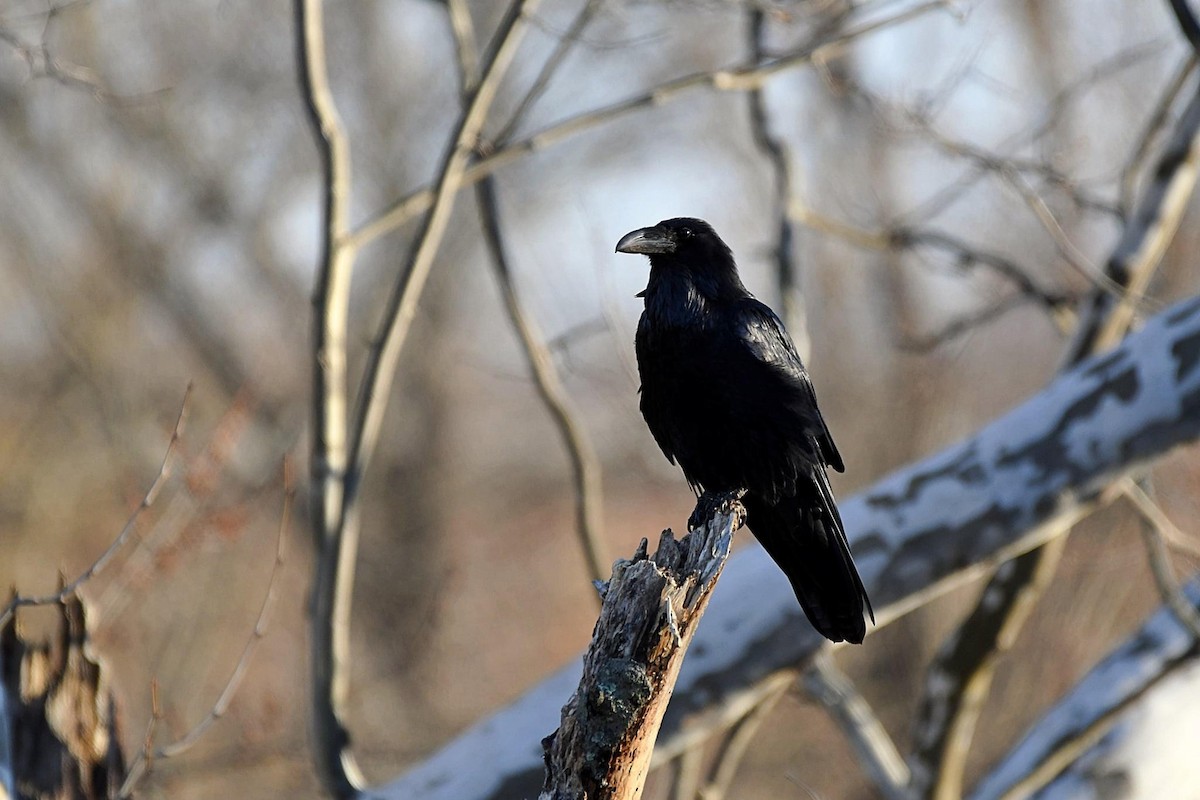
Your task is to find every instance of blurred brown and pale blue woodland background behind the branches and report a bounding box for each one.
[0,0,1200,799]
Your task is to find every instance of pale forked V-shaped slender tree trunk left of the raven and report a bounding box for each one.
[302,0,549,798]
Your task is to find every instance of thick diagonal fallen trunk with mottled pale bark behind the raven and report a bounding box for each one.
[374,299,1200,800]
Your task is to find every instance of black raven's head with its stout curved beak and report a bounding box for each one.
[617,217,745,296]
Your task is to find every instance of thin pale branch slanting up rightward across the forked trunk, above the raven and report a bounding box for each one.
[347,0,950,253]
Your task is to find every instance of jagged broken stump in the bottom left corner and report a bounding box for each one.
[0,595,125,800]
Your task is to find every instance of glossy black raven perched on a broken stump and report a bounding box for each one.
[617,218,875,644]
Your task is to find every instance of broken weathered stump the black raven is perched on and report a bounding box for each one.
[541,497,745,800]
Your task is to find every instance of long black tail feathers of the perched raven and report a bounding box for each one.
[742,468,875,644]
